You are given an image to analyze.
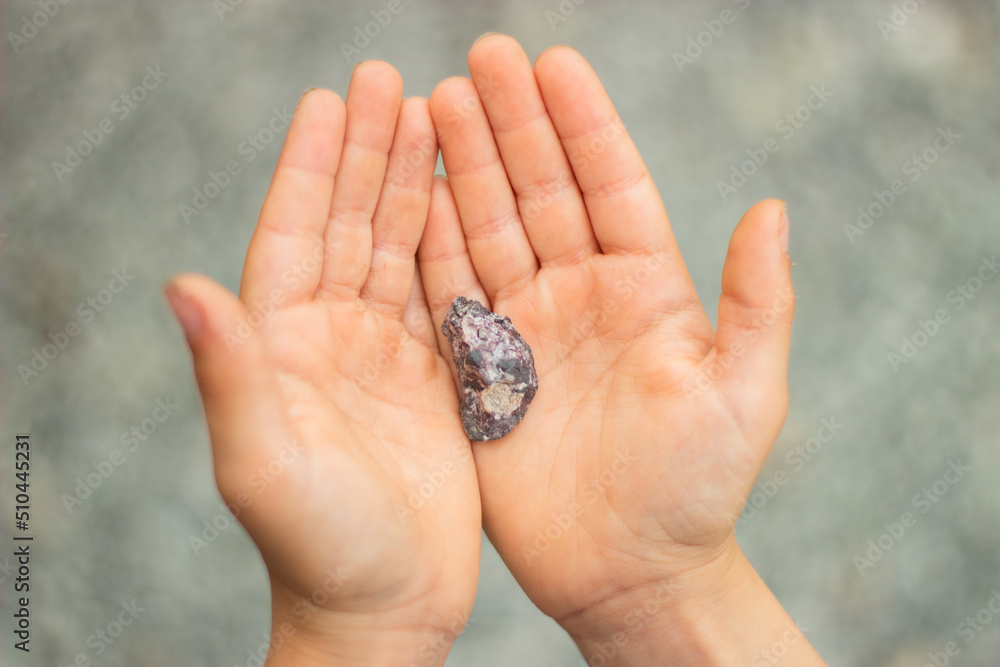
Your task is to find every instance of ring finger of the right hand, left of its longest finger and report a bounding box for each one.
[424,77,538,299]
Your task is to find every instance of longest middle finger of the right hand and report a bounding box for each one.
[469,35,600,266]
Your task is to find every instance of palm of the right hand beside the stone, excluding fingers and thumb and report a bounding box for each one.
[476,257,747,617]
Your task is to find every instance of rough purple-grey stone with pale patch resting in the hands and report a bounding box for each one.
[441,296,538,440]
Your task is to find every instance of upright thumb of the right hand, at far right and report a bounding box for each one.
[715,199,795,438]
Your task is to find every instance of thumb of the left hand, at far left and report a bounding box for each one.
[166,274,291,501]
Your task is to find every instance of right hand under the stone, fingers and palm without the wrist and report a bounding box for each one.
[420,37,787,618]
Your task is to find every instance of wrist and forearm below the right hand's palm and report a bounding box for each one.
[559,539,825,667]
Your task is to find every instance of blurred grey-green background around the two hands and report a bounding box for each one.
[0,0,1000,667]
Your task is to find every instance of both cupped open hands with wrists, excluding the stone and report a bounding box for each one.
[167,35,824,667]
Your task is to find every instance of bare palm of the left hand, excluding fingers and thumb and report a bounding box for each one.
[246,300,479,598]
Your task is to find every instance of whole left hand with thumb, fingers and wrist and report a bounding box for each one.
[168,62,481,665]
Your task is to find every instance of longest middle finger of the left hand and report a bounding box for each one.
[317,61,403,298]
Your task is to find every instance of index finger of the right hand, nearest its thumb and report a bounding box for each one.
[535,47,683,260]
